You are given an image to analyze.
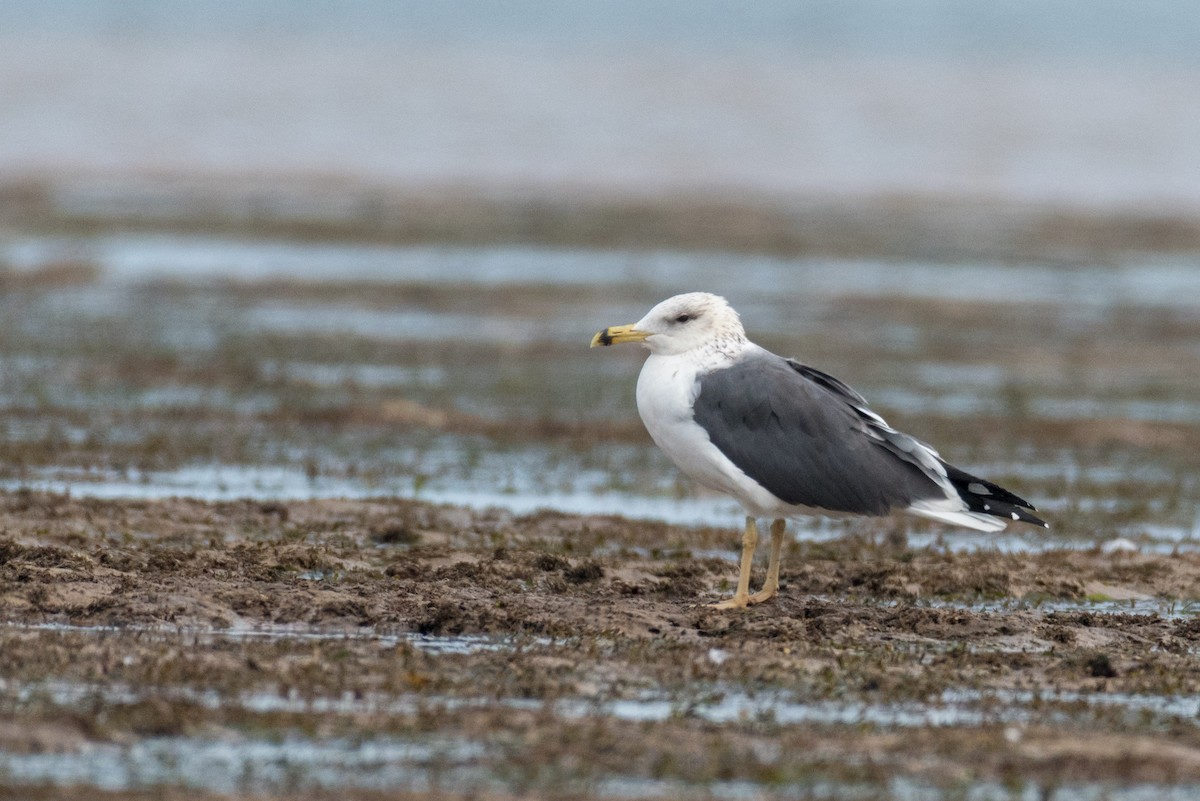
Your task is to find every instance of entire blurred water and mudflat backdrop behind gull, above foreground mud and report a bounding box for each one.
[0,0,1200,548]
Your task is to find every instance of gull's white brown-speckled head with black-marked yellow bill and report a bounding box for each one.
[592,293,745,356]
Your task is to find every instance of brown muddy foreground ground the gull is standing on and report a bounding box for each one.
[0,493,1200,797]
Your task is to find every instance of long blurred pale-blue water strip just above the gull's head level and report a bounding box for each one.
[11,234,1200,311]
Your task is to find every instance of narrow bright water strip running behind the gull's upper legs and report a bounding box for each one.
[0,455,1200,554]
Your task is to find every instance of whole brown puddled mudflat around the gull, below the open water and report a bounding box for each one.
[0,176,1200,801]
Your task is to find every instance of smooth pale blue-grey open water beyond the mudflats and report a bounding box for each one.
[7,0,1200,203]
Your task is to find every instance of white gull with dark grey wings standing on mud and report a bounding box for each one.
[592,293,1049,609]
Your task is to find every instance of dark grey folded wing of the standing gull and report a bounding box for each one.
[692,353,947,514]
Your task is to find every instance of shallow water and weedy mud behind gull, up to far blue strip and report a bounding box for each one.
[0,234,1200,552]
